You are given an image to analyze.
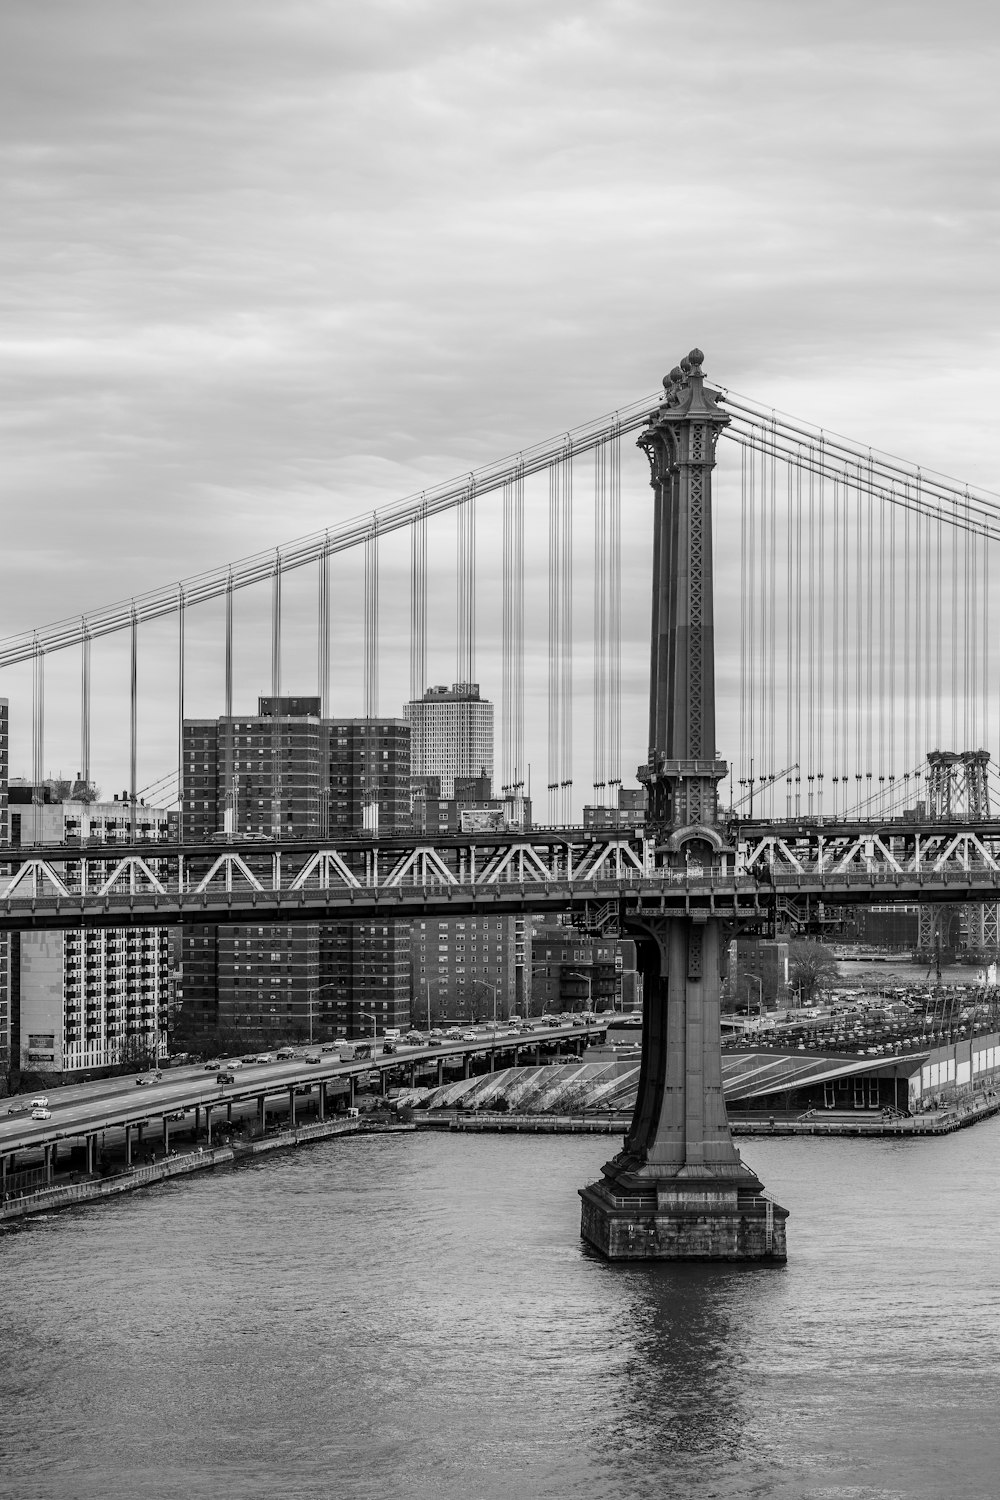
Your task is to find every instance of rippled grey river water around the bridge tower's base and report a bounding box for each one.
[0,1121,1000,1500]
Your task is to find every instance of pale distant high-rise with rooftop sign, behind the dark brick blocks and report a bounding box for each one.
[403,683,493,800]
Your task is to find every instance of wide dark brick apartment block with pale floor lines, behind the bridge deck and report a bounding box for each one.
[180,698,409,1047]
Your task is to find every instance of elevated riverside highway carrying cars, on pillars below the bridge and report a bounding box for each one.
[0,1020,607,1176]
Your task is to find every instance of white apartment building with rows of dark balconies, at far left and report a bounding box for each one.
[9,783,177,1076]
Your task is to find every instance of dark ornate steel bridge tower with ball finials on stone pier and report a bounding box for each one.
[580,350,787,1260]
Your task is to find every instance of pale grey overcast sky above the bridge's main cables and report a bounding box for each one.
[0,0,1000,810]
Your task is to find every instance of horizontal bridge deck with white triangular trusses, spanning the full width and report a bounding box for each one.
[0,819,1000,930]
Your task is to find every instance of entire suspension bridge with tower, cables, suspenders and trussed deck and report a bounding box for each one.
[0,350,1000,1260]
